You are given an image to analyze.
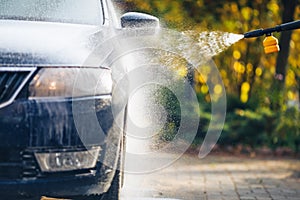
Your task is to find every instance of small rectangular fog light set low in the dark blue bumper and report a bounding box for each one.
[34,147,101,172]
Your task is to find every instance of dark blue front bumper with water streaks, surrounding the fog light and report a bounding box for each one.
[0,96,122,199]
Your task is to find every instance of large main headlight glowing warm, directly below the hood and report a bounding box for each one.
[29,67,112,98]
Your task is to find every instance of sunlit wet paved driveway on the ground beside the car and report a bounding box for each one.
[121,154,300,200]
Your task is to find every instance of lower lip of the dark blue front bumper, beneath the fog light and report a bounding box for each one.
[0,162,114,199]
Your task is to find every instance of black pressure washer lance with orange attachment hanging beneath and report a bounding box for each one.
[244,20,300,54]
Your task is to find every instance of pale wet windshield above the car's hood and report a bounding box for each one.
[0,0,103,25]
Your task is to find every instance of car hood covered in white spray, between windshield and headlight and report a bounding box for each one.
[0,20,110,66]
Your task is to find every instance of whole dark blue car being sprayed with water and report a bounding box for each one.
[0,0,158,199]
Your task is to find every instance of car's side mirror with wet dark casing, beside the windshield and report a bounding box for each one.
[121,12,159,28]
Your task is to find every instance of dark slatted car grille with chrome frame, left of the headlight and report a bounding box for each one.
[0,67,35,108]
